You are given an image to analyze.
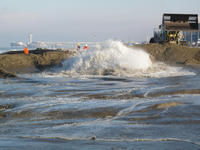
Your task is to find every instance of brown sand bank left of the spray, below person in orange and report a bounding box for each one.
[0,50,73,78]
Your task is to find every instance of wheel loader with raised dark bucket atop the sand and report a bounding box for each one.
[149,13,199,45]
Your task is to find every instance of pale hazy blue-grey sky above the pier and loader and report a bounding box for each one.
[0,0,200,47]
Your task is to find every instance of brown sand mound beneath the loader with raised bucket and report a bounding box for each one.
[134,43,200,65]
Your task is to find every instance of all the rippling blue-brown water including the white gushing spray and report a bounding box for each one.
[0,41,200,150]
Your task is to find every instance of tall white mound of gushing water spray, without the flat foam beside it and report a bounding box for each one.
[62,40,152,75]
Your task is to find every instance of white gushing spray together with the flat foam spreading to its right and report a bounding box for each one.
[54,40,195,78]
